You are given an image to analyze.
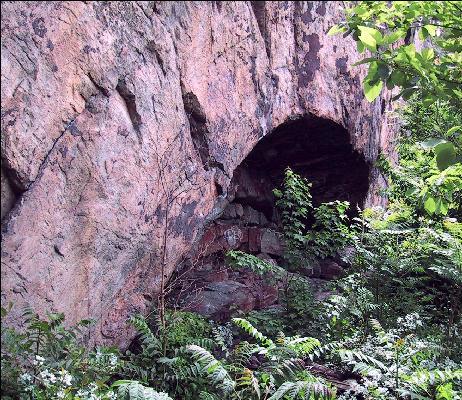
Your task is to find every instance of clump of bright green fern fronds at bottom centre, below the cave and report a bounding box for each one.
[188,318,333,400]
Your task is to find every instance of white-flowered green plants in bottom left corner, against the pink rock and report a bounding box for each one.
[2,306,146,400]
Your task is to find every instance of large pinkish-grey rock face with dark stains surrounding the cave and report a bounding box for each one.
[1,2,392,346]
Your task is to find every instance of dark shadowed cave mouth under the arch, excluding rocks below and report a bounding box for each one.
[226,115,370,228]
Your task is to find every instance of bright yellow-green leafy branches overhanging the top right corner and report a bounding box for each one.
[329,1,462,107]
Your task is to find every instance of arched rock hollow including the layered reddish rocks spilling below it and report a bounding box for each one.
[175,115,370,319]
